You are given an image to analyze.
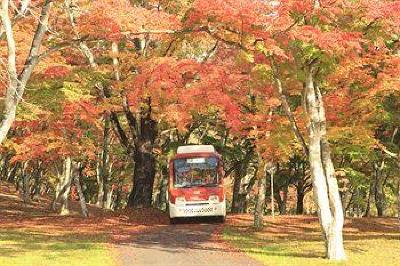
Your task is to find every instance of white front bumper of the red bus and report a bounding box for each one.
[169,201,226,218]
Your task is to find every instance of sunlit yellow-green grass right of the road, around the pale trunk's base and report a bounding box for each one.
[224,224,400,266]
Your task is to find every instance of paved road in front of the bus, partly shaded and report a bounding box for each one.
[116,218,261,266]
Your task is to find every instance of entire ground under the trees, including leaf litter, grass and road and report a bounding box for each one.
[0,182,400,266]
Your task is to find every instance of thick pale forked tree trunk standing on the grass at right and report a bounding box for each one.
[305,69,346,260]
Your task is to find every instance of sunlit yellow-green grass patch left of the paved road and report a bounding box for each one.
[0,229,115,266]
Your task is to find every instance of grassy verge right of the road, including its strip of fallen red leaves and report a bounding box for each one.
[224,217,400,266]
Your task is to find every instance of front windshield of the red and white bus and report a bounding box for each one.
[174,157,218,188]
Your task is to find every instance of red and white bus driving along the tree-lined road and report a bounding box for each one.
[167,145,226,223]
